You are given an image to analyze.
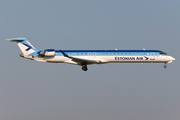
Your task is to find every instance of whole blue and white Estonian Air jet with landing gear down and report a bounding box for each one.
[7,37,175,71]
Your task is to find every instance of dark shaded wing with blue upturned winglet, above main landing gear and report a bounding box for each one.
[61,50,101,65]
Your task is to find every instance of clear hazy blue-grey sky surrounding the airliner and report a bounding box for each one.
[0,0,180,120]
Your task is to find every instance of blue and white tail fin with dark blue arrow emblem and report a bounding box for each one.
[7,37,39,56]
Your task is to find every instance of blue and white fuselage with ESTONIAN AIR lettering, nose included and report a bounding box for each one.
[26,50,175,64]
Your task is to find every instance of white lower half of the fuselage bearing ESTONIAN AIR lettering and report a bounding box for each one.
[40,56,168,65]
